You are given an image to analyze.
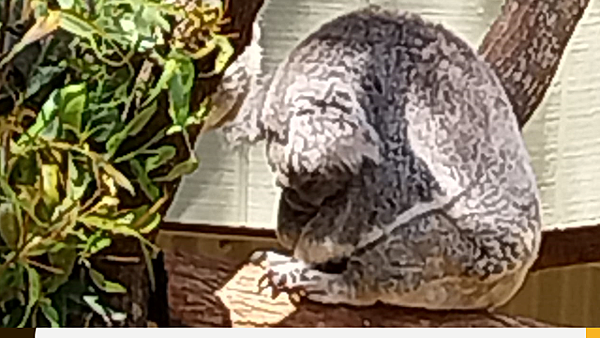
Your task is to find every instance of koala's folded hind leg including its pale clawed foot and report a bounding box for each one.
[248,209,535,309]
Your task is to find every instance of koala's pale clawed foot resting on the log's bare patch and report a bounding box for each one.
[250,251,325,298]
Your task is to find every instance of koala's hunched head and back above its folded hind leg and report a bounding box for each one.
[261,6,540,267]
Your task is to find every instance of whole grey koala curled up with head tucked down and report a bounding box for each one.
[222,6,541,309]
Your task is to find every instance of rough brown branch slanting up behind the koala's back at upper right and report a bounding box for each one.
[479,0,589,127]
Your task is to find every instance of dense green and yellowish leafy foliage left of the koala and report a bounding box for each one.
[0,0,232,327]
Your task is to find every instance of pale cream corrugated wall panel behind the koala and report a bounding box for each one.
[167,0,600,232]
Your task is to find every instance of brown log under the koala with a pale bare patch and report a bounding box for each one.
[165,248,551,327]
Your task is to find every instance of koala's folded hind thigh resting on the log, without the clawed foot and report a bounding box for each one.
[348,210,539,310]
